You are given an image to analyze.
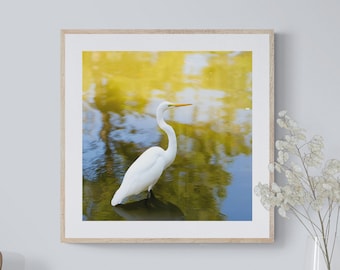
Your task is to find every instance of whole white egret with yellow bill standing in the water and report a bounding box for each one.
[111,101,191,206]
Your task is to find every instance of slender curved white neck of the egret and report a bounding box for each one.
[157,107,177,167]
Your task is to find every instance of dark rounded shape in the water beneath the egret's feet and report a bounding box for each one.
[112,192,184,221]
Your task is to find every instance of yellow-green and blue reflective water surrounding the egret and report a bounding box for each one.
[83,52,252,220]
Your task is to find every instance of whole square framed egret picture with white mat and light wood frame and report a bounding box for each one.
[61,30,274,243]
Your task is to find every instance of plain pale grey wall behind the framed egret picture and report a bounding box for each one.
[0,0,340,270]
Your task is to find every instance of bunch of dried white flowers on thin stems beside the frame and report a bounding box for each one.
[254,111,340,268]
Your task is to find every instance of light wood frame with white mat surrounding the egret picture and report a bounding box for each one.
[61,30,274,243]
